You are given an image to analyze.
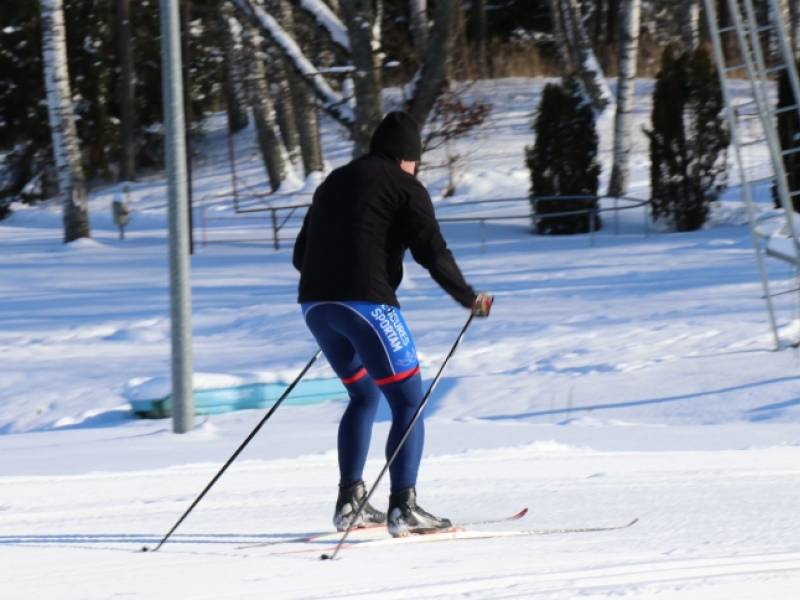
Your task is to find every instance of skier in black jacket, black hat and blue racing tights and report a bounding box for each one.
[293,111,492,537]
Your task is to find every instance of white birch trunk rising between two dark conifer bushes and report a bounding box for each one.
[608,0,641,196]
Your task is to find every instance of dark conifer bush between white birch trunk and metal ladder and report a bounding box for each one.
[646,46,730,231]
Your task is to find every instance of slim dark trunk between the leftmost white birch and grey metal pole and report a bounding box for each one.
[116,0,136,181]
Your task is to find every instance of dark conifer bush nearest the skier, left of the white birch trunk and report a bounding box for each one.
[525,81,601,234]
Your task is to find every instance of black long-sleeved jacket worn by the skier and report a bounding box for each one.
[293,154,475,307]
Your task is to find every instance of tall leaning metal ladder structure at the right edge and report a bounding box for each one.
[704,0,800,349]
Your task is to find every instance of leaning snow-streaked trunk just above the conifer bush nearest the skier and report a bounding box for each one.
[550,0,613,112]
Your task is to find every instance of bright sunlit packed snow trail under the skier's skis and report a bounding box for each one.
[0,438,800,600]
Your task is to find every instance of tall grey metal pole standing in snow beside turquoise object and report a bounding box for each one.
[159,0,194,433]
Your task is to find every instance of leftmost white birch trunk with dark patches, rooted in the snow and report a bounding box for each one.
[39,0,90,242]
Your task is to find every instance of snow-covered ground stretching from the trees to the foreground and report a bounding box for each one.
[0,79,800,600]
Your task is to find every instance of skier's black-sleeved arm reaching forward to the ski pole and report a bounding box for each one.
[406,186,477,308]
